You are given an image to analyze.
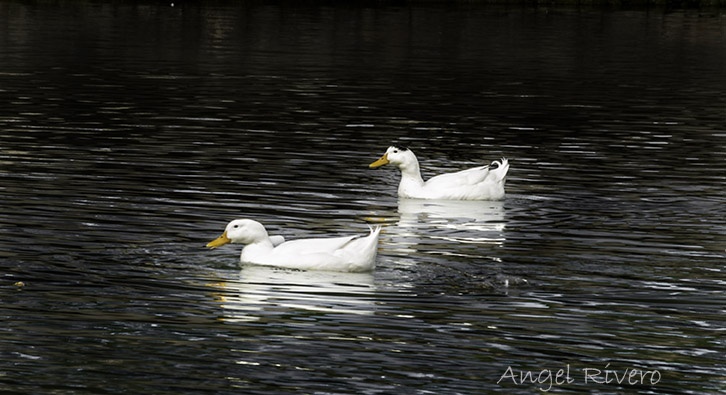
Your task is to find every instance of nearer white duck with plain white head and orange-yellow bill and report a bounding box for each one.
[207,219,381,273]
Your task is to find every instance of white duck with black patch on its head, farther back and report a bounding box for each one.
[369,146,509,200]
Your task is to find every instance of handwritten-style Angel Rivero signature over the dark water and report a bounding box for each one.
[497,363,662,392]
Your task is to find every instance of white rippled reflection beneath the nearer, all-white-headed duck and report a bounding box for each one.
[210,265,375,321]
